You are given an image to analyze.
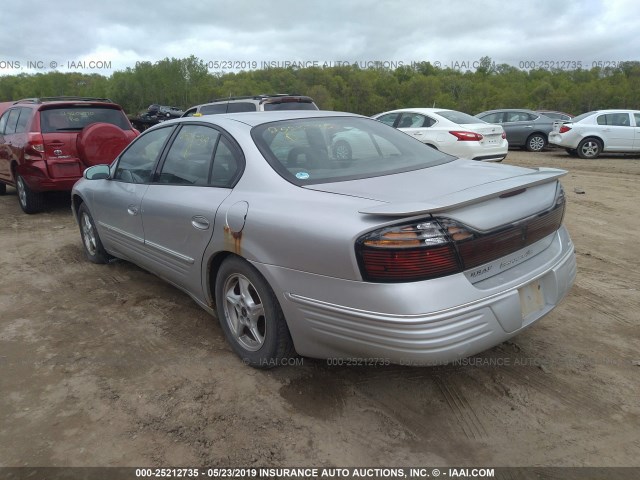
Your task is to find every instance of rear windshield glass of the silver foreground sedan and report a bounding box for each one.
[251,117,454,185]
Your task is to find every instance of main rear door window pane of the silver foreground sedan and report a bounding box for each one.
[158,125,220,185]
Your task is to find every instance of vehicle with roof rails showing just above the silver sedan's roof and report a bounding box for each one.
[183,93,318,117]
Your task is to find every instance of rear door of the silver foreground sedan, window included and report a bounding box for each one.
[142,124,241,292]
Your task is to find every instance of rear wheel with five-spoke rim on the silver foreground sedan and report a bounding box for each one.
[215,257,295,369]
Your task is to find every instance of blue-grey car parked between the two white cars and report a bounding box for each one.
[476,109,554,152]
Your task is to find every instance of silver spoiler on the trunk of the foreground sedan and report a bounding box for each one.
[359,168,567,217]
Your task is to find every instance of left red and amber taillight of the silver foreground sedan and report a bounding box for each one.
[356,221,462,282]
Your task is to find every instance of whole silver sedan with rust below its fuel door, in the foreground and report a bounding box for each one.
[72,111,576,368]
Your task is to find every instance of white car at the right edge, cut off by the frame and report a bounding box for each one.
[549,110,640,158]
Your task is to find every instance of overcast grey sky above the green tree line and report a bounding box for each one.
[0,0,640,75]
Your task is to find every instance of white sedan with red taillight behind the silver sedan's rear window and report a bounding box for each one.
[372,108,509,162]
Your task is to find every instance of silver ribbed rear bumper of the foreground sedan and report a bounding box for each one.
[256,227,576,365]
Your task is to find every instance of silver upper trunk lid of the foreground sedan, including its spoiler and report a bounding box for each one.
[305,160,567,231]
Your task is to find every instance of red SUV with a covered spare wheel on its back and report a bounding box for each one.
[0,97,139,213]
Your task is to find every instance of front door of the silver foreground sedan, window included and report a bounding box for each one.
[89,126,174,262]
